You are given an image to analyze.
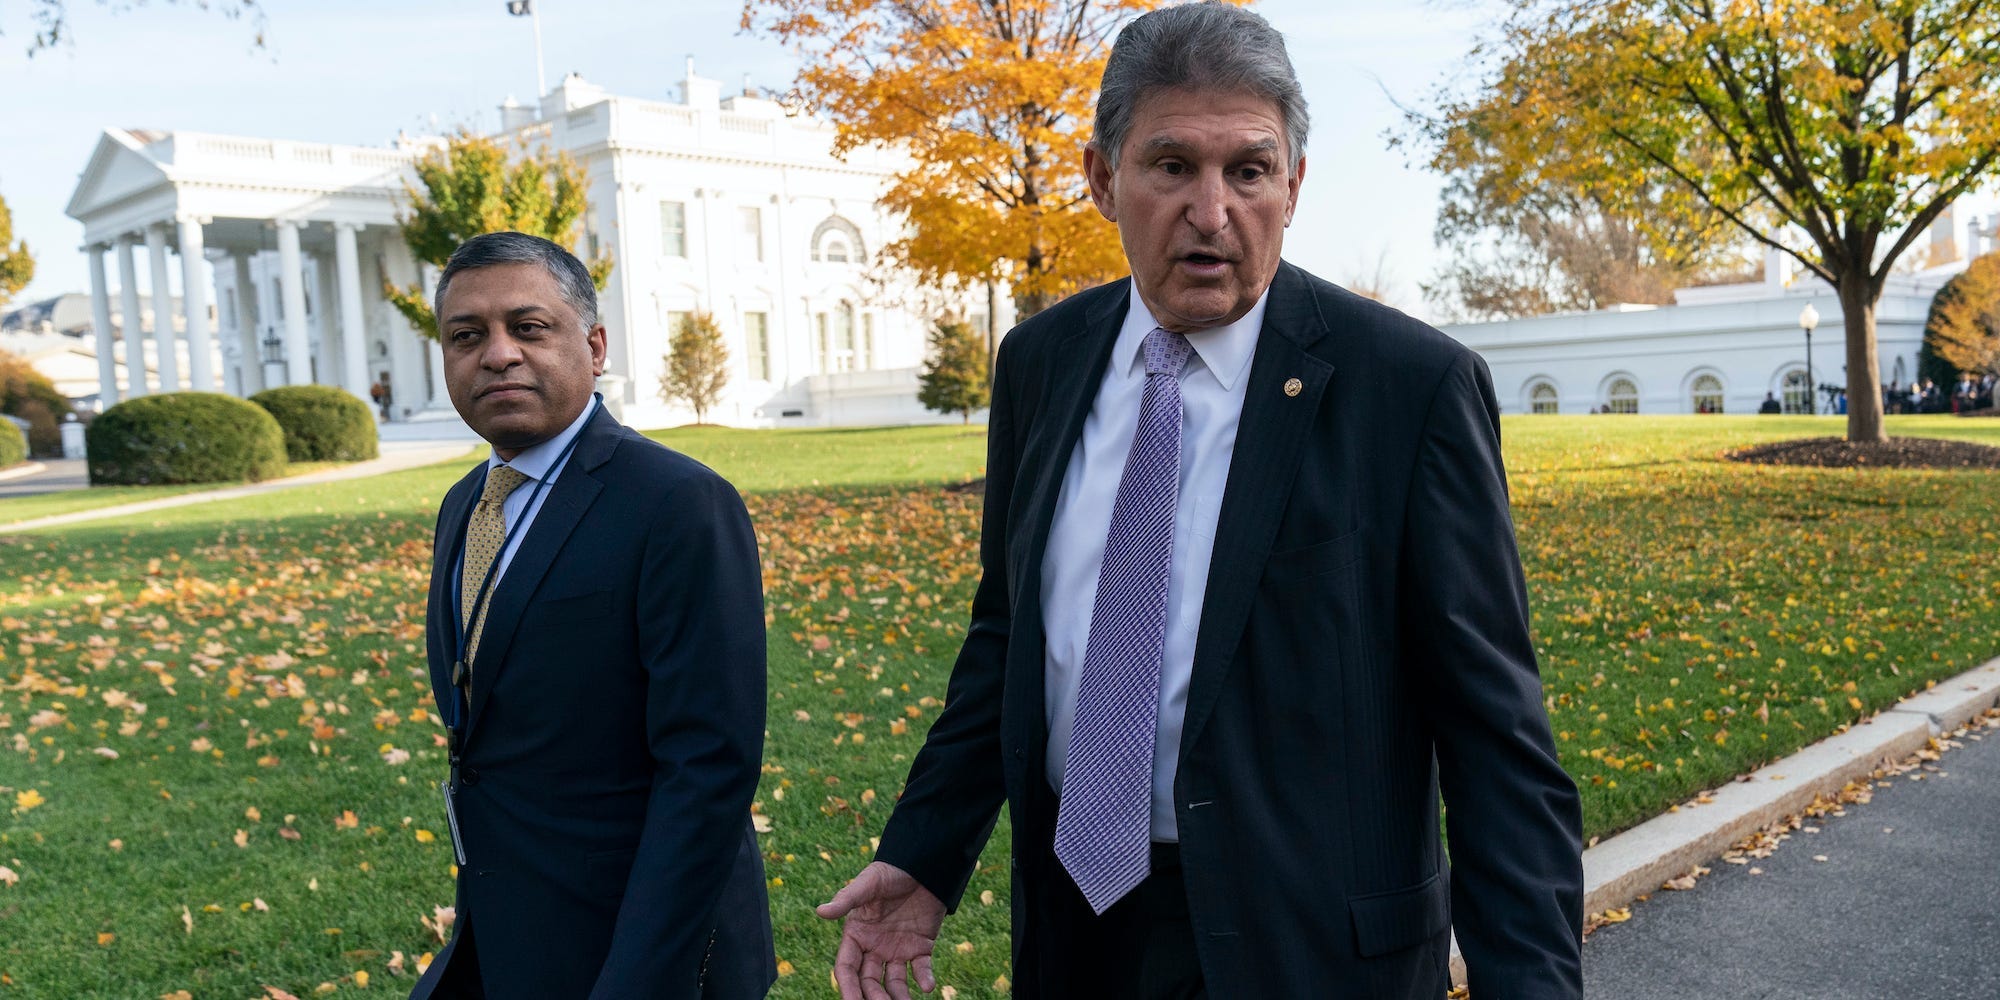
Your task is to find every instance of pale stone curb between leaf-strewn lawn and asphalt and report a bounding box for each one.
[1452,658,2000,986]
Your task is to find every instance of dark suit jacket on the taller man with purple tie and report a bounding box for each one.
[878,264,1582,1000]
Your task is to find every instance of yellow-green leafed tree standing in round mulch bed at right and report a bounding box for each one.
[1442,0,2000,442]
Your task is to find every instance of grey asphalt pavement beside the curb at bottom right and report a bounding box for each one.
[1584,716,2000,1000]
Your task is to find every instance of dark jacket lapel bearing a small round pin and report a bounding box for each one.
[1180,264,1334,754]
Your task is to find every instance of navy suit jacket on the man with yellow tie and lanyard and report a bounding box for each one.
[414,412,776,1000]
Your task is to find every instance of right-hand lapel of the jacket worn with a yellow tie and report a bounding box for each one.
[466,404,624,738]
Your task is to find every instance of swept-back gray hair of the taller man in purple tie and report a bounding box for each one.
[1090,0,1310,170]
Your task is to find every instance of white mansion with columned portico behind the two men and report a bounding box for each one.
[68,64,1010,426]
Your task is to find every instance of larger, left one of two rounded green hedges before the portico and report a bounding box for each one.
[84,392,284,486]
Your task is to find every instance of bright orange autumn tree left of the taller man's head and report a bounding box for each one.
[742,0,1216,318]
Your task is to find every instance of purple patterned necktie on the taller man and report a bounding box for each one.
[1056,330,1194,914]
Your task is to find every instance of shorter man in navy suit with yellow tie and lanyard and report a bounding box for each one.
[412,232,776,1000]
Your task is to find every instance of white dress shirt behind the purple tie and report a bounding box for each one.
[1042,290,1270,842]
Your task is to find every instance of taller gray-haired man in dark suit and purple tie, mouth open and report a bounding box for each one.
[820,2,1582,1000]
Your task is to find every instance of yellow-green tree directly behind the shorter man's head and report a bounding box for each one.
[382,132,612,340]
